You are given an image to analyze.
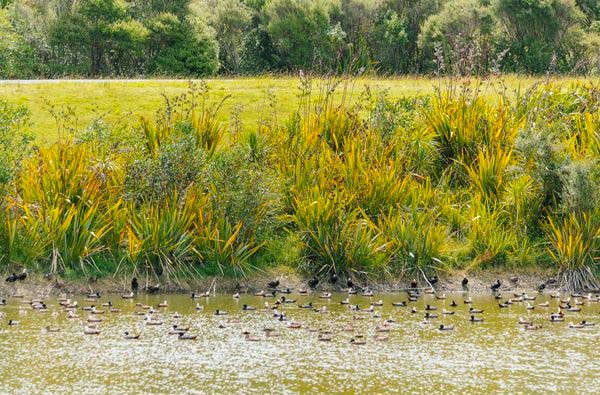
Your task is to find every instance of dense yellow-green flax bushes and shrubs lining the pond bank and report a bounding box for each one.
[0,79,600,289]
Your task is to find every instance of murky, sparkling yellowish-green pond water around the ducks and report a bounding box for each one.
[0,294,600,394]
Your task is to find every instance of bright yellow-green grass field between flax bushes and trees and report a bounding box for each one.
[0,76,599,143]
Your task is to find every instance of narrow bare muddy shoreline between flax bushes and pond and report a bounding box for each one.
[0,270,580,297]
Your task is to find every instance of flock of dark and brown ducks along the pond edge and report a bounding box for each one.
[0,272,600,345]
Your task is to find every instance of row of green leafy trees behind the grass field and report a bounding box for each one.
[0,0,600,78]
